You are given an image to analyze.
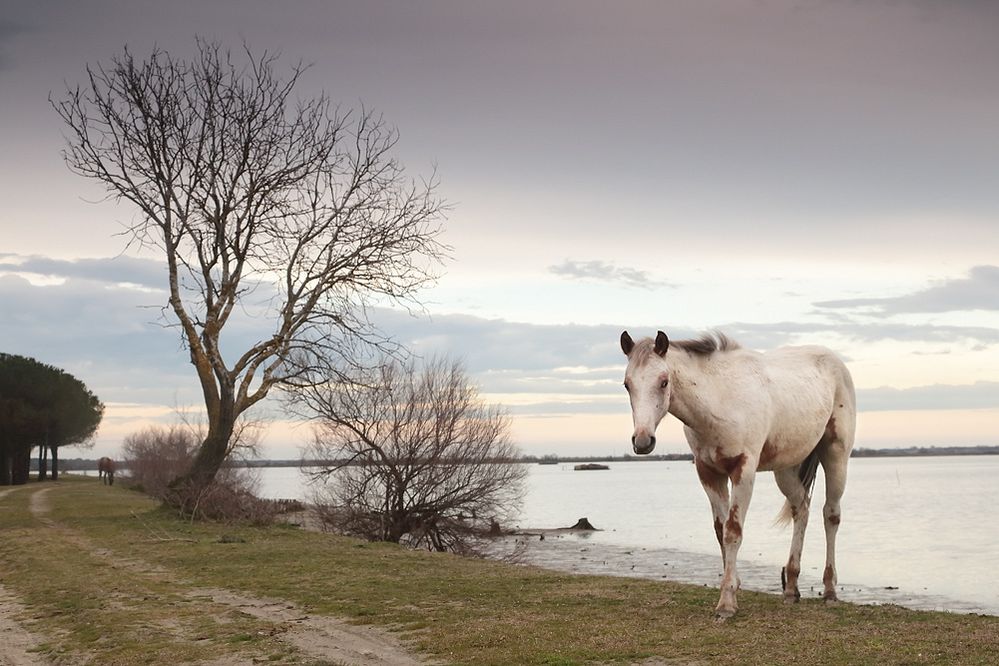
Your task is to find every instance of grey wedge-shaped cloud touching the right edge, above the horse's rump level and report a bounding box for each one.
[815,266,999,316]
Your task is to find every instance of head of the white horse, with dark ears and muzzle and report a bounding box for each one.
[621,331,671,455]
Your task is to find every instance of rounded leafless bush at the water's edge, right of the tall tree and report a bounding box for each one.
[297,359,527,551]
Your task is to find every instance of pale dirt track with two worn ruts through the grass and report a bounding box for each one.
[0,486,427,666]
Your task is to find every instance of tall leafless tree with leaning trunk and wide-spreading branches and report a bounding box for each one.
[52,40,446,498]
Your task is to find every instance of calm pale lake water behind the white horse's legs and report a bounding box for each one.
[260,456,999,614]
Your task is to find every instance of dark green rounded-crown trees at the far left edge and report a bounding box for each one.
[0,353,104,485]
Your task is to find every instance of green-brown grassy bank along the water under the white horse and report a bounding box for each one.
[0,479,999,664]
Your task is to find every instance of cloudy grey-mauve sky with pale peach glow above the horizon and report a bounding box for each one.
[0,0,999,458]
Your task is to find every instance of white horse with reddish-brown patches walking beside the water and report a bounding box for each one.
[621,331,856,618]
